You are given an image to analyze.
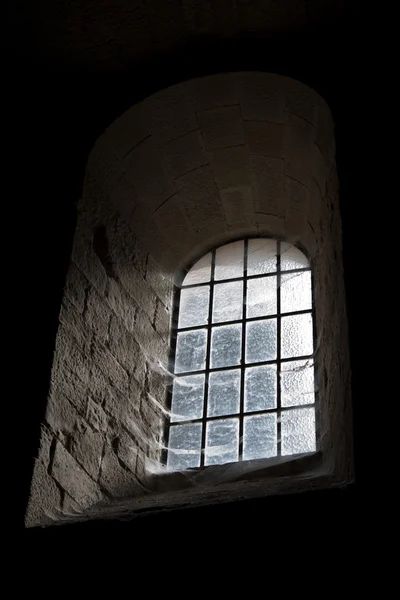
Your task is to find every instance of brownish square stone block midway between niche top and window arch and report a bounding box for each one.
[211,146,250,190]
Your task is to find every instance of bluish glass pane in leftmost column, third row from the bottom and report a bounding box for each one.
[175,329,207,373]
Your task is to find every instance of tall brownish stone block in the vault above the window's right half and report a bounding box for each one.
[251,155,286,217]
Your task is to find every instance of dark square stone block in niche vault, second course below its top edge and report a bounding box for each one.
[198,106,244,150]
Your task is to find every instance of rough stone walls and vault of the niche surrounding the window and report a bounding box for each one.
[26,72,352,526]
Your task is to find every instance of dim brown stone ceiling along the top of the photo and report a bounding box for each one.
[28,0,354,69]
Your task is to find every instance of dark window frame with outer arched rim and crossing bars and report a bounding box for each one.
[161,233,321,473]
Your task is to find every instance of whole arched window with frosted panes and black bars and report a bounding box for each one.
[167,238,316,470]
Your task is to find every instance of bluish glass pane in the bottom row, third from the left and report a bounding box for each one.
[243,413,276,460]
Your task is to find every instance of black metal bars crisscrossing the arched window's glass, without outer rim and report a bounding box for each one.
[164,238,319,467]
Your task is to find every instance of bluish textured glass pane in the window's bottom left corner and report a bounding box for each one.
[167,423,202,470]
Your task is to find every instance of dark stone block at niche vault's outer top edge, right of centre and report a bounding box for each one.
[236,73,284,123]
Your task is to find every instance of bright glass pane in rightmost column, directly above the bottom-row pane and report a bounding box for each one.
[281,359,315,406]
